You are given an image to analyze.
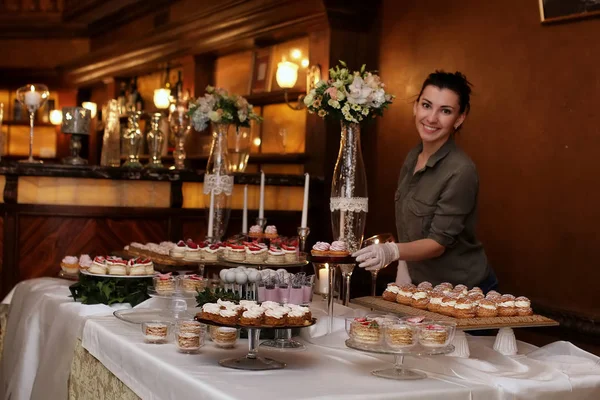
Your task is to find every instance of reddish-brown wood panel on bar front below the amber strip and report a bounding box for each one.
[18,215,168,280]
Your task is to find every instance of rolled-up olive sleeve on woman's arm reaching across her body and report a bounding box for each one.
[428,165,479,247]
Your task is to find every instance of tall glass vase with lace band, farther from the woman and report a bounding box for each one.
[204,124,233,241]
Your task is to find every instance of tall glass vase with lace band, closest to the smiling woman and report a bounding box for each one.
[329,122,369,252]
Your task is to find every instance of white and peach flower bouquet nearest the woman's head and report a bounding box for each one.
[304,61,395,123]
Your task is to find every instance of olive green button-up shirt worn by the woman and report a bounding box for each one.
[395,138,490,287]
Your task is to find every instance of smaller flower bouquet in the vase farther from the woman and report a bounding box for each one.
[189,86,262,131]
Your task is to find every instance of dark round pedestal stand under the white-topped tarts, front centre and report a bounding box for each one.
[196,318,316,371]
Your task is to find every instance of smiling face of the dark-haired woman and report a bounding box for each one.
[413,85,466,144]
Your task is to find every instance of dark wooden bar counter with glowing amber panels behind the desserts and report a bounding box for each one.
[0,163,325,296]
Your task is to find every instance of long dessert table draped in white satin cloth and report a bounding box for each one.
[0,278,600,400]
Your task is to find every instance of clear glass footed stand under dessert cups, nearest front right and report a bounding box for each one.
[346,339,454,380]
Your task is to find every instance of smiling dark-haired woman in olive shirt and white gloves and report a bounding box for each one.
[354,71,498,292]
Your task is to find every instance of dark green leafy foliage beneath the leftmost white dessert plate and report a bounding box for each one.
[69,274,152,307]
